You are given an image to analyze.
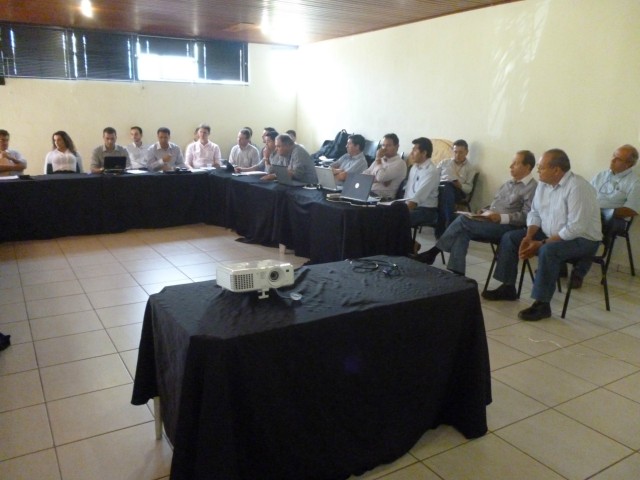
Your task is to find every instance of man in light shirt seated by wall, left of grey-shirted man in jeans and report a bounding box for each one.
[435,140,476,238]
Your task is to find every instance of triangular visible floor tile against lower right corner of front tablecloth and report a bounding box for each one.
[487,380,548,431]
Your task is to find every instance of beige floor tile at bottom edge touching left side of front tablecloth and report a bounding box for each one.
[56,422,172,480]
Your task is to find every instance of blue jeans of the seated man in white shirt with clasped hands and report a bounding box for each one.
[493,230,600,302]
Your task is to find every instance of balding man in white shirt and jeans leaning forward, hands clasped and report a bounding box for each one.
[482,149,602,321]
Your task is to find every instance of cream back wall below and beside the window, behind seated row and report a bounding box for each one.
[0,44,297,174]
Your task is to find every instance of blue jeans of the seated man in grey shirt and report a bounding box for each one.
[436,215,522,275]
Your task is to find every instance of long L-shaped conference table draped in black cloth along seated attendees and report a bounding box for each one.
[0,170,412,263]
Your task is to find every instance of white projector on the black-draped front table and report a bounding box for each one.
[216,260,293,298]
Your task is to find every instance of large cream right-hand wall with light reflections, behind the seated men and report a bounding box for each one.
[298,0,640,270]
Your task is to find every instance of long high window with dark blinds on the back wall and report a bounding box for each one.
[0,24,248,83]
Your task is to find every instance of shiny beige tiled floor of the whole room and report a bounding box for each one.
[0,225,640,480]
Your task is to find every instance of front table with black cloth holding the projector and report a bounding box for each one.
[132,256,491,480]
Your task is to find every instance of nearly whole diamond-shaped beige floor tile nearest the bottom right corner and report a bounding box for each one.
[496,410,632,480]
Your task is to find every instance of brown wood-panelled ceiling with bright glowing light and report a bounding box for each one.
[0,0,516,45]
